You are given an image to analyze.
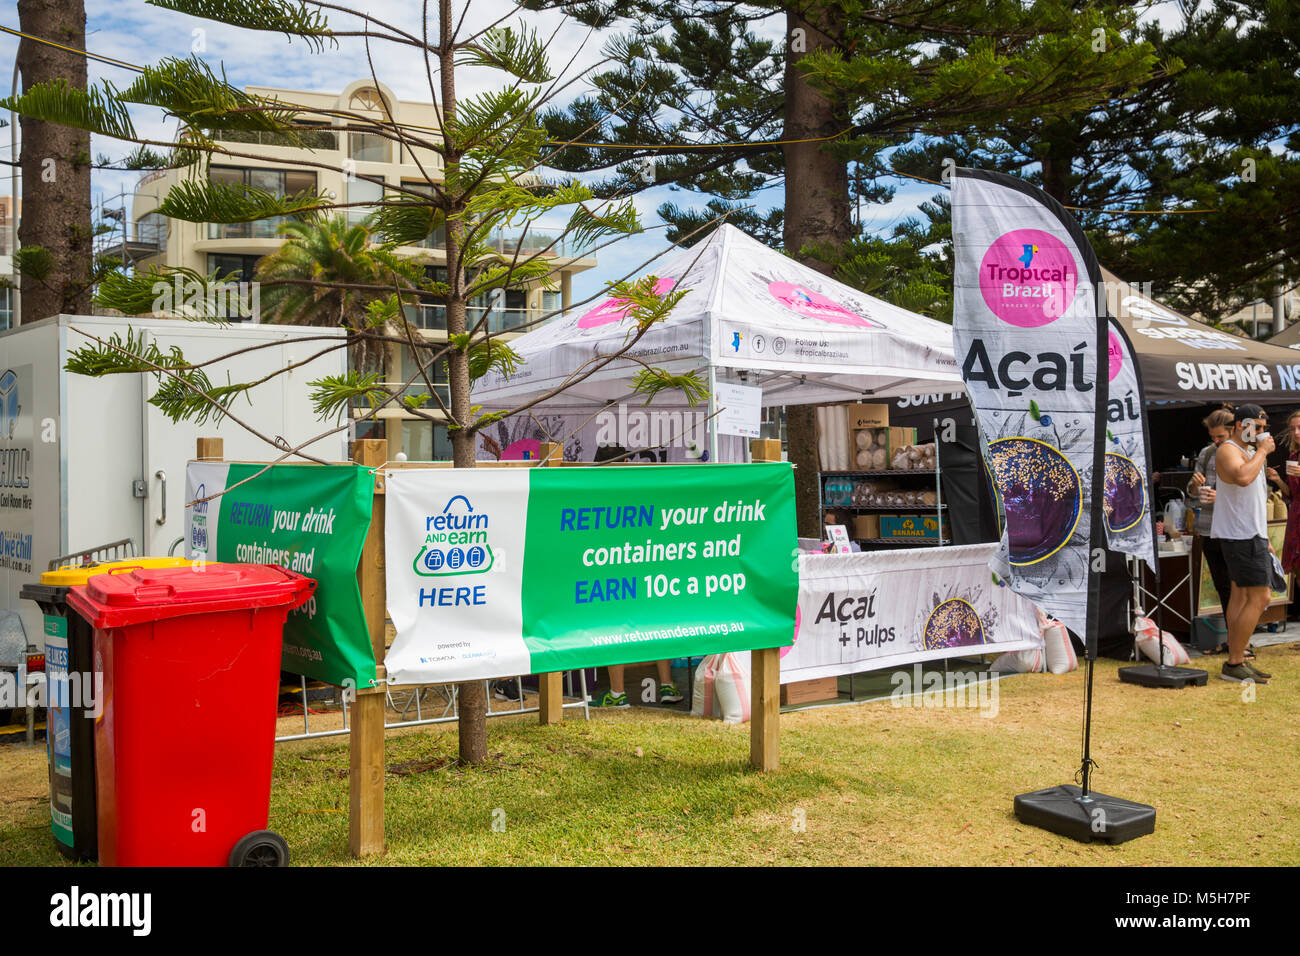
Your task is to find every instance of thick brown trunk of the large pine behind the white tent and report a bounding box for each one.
[783,9,853,537]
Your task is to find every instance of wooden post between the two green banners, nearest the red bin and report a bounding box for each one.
[348,438,389,857]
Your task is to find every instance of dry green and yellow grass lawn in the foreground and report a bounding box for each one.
[0,644,1300,866]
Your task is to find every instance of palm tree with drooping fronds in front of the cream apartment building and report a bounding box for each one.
[256,215,420,373]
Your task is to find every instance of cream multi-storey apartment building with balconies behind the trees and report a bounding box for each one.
[129,79,595,460]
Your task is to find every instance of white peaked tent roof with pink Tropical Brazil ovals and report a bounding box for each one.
[473,225,965,408]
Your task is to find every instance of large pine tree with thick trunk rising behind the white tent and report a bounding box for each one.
[534,0,1158,535]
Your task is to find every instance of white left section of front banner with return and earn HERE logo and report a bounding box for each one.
[384,468,530,684]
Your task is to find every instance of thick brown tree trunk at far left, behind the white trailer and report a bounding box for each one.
[14,0,92,324]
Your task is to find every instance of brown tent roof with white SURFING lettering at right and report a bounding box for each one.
[1101,269,1300,405]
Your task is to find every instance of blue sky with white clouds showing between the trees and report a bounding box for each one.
[0,0,1179,300]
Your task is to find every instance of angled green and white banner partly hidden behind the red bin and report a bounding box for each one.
[185,462,374,687]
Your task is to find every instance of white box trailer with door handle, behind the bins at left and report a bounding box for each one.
[0,315,347,650]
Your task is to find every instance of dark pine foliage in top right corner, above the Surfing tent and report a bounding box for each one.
[893,0,1300,320]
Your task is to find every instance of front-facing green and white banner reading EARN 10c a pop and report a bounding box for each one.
[385,464,798,684]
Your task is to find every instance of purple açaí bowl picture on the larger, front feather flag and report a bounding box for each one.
[988,436,1083,564]
